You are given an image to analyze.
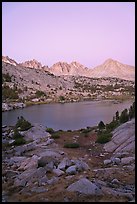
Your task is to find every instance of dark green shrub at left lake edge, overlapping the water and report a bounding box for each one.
[16,116,32,131]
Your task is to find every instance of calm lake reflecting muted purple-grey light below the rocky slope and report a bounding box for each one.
[2,101,132,130]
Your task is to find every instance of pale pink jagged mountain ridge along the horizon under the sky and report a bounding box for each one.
[2,57,135,81]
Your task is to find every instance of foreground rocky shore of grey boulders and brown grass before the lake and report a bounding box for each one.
[2,119,135,202]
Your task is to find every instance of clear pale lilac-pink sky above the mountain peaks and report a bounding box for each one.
[2,2,135,68]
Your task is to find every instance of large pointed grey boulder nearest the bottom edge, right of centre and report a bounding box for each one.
[67,178,101,195]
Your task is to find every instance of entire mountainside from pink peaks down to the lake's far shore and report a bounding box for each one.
[2,56,135,107]
